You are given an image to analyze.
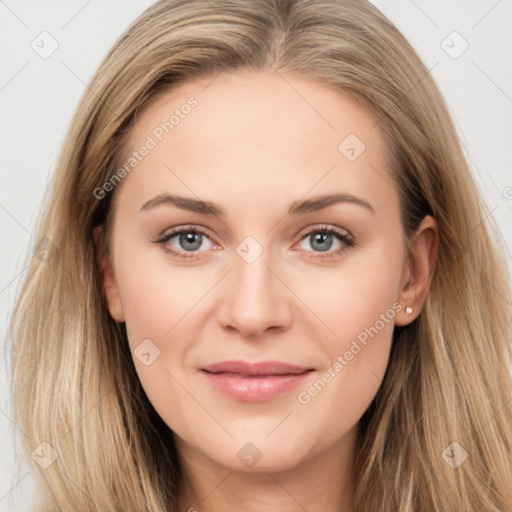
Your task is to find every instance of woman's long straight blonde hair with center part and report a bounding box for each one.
[11,0,512,512]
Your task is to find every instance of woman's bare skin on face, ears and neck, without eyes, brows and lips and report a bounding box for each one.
[95,70,438,512]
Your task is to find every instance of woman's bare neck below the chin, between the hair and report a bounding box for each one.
[175,429,357,512]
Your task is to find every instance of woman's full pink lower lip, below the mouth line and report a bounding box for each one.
[201,370,311,402]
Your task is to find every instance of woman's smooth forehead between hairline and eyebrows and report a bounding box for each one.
[119,70,393,216]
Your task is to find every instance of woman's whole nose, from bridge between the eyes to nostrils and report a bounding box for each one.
[220,237,291,335]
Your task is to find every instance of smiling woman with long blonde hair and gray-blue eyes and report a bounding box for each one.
[12,0,512,512]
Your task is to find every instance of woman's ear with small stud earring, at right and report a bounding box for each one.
[395,215,439,325]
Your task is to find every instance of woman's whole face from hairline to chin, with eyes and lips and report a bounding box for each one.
[99,71,428,470]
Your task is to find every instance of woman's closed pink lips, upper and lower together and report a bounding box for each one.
[201,361,314,402]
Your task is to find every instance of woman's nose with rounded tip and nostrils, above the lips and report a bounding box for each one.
[217,252,293,337]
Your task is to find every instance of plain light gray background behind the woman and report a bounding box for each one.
[0,0,512,512]
